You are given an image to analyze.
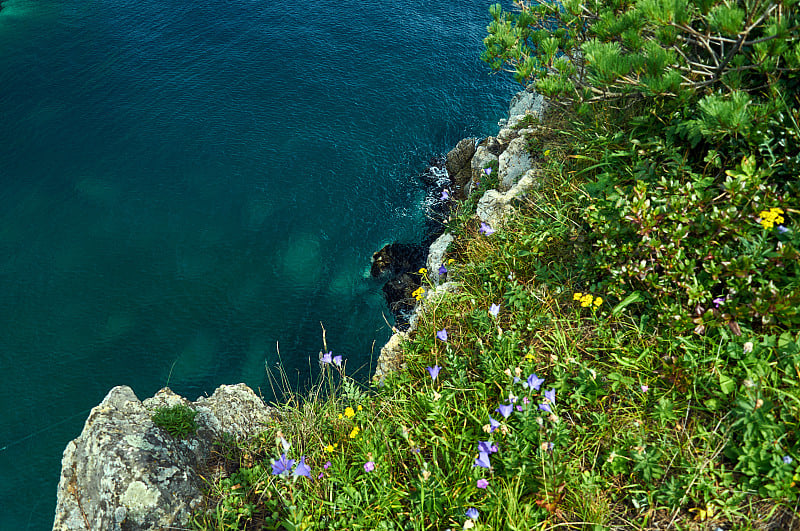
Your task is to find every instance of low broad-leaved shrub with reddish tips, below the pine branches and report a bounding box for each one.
[586,142,800,335]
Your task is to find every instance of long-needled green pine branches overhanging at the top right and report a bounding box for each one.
[481,0,800,110]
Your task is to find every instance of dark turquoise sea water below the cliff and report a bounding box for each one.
[0,0,516,530]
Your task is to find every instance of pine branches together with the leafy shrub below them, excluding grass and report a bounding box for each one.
[483,0,800,334]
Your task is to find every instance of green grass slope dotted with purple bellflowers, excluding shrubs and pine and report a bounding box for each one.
[189,106,800,530]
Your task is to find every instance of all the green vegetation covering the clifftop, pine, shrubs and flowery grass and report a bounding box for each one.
[189,0,800,531]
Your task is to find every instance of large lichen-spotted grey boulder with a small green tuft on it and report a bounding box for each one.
[53,384,271,531]
